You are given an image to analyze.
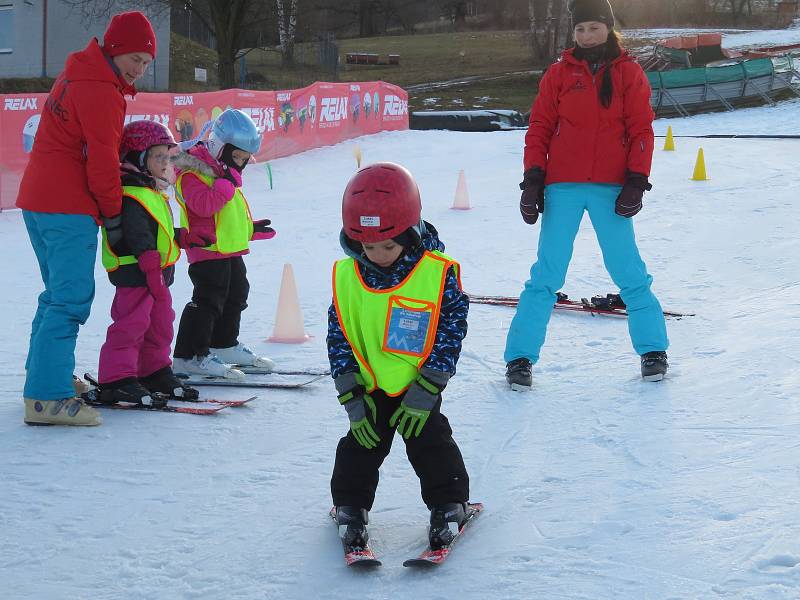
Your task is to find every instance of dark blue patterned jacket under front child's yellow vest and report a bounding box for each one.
[327,222,469,379]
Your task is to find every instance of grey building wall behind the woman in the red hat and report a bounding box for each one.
[0,0,170,90]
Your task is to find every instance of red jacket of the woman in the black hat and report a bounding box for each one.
[524,49,653,185]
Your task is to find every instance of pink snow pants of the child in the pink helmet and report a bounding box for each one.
[97,287,175,383]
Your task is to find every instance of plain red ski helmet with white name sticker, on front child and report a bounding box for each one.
[342,162,422,244]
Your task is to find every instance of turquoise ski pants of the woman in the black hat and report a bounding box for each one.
[504,183,669,363]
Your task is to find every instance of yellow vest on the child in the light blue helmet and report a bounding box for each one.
[175,171,253,254]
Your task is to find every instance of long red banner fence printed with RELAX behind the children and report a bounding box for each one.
[0,81,408,209]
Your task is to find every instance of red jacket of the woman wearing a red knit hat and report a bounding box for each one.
[17,39,136,223]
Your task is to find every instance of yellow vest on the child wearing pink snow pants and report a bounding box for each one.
[100,185,181,272]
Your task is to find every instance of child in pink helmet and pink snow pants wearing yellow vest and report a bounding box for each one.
[98,121,200,406]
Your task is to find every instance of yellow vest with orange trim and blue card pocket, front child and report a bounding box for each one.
[333,251,461,396]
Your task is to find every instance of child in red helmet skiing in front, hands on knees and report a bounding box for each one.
[327,163,469,549]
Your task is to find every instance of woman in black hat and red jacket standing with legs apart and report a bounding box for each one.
[505,0,669,390]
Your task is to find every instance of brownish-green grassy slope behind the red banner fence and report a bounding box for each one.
[170,31,538,110]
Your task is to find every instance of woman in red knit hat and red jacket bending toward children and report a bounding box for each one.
[17,12,156,425]
